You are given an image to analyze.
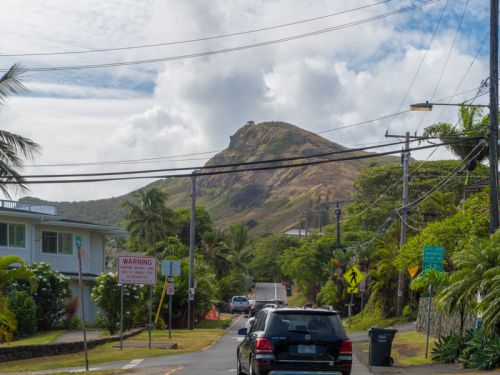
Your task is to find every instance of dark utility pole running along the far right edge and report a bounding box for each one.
[489,0,499,233]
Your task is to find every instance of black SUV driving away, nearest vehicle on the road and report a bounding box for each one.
[236,308,352,375]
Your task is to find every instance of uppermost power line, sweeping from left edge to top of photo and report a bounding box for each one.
[0,0,392,57]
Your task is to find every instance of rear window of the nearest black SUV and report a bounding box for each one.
[267,311,346,339]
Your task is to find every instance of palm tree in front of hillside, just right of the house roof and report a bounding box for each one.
[123,188,174,251]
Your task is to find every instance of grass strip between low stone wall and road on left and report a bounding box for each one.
[0,328,225,373]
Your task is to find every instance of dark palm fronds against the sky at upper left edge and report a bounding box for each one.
[0,64,40,197]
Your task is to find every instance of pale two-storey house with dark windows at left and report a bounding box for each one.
[0,200,126,322]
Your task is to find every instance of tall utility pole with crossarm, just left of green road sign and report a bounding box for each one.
[385,132,412,316]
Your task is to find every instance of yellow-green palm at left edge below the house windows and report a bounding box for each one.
[0,255,36,342]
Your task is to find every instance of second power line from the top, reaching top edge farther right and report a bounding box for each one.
[0,0,442,72]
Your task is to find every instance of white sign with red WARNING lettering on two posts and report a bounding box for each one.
[118,255,156,349]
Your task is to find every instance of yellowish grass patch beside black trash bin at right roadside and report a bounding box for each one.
[356,331,436,366]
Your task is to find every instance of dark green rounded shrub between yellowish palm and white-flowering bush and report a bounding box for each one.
[8,291,37,337]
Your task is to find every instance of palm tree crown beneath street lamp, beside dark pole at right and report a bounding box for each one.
[424,104,489,183]
